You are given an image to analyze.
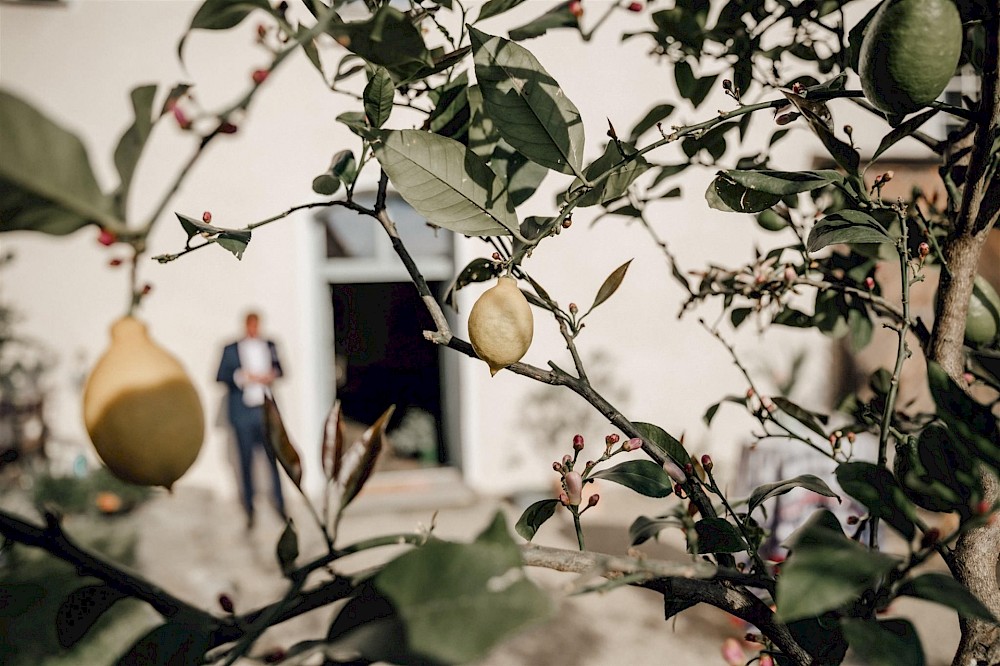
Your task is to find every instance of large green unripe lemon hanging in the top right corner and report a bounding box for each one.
[858,0,962,114]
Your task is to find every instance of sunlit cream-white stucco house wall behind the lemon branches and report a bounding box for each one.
[0,0,928,493]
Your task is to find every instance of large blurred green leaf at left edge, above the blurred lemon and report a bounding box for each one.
[0,90,123,236]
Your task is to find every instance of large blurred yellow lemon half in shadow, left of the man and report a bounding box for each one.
[83,317,205,489]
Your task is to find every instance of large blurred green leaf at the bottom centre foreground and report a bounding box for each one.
[375,513,552,664]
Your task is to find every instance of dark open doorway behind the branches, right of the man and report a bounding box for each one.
[330,282,446,468]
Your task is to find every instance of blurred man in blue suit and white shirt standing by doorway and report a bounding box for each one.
[215,312,285,529]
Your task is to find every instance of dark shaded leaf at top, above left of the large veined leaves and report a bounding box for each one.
[327,4,434,78]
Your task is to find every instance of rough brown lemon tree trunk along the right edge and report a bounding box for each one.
[929,9,1000,666]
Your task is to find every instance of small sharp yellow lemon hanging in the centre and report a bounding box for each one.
[469,276,535,375]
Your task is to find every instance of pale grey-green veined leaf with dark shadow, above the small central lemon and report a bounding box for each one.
[372,130,519,236]
